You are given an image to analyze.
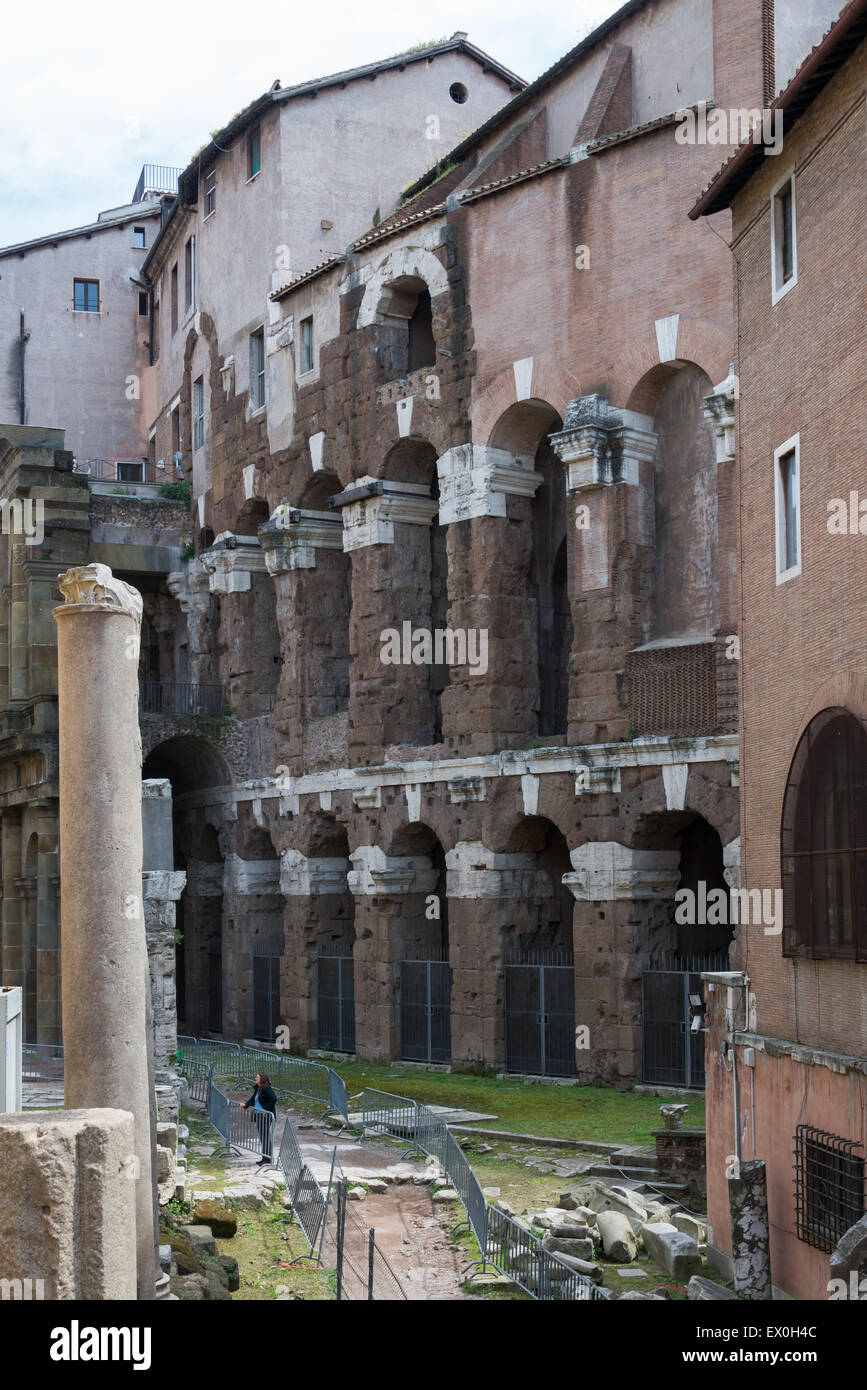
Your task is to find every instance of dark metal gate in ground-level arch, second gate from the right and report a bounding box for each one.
[504,951,577,1076]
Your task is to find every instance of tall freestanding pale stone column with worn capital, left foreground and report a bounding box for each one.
[54,564,156,1300]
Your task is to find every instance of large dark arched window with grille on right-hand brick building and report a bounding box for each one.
[781,709,867,960]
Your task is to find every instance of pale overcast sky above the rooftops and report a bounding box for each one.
[0,0,622,246]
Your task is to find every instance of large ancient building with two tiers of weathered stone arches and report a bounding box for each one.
[0,0,844,1084]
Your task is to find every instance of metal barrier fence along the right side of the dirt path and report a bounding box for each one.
[361,1090,611,1302]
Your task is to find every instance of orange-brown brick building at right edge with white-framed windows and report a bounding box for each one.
[693,0,867,1298]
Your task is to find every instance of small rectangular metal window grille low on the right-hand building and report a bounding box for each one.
[795,1125,867,1250]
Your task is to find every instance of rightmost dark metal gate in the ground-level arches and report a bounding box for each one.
[642,958,728,1091]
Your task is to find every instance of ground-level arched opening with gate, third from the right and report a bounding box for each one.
[389,824,452,1062]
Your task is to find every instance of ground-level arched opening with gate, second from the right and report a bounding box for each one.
[503,816,575,1076]
